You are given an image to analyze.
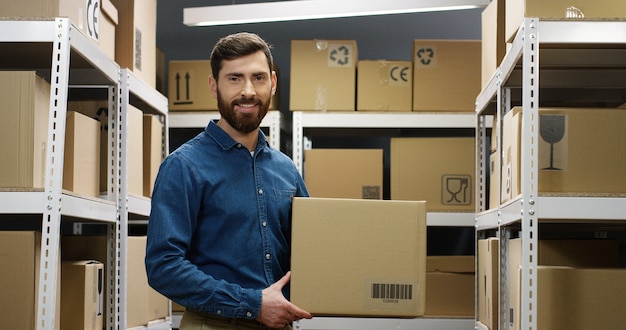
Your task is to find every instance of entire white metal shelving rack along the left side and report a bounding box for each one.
[0,18,171,330]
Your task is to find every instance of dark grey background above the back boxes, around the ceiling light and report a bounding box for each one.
[157,0,482,104]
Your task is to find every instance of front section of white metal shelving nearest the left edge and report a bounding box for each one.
[0,18,122,329]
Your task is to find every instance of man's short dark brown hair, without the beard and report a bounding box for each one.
[211,32,274,80]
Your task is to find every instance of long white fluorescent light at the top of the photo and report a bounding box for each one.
[183,0,490,26]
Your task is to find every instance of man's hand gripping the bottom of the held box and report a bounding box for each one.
[257,272,313,329]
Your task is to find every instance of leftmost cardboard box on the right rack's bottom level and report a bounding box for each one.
[476,237,500,330]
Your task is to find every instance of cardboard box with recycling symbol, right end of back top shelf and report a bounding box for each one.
[413,40,481,112]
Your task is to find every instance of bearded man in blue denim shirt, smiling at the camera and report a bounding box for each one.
[145,33,311,330]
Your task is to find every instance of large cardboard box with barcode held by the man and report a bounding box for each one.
[291,198,426,317]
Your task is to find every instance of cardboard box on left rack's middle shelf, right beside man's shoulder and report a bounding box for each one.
[143,115,164,197]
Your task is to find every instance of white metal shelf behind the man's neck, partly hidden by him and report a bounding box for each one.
[169,110,286,150]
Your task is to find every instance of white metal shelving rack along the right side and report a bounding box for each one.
[476,18,626,329]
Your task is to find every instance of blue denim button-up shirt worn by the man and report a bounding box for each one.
[145,121,308,319]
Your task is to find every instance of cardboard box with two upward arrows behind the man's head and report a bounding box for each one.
[168,60,280,111]
